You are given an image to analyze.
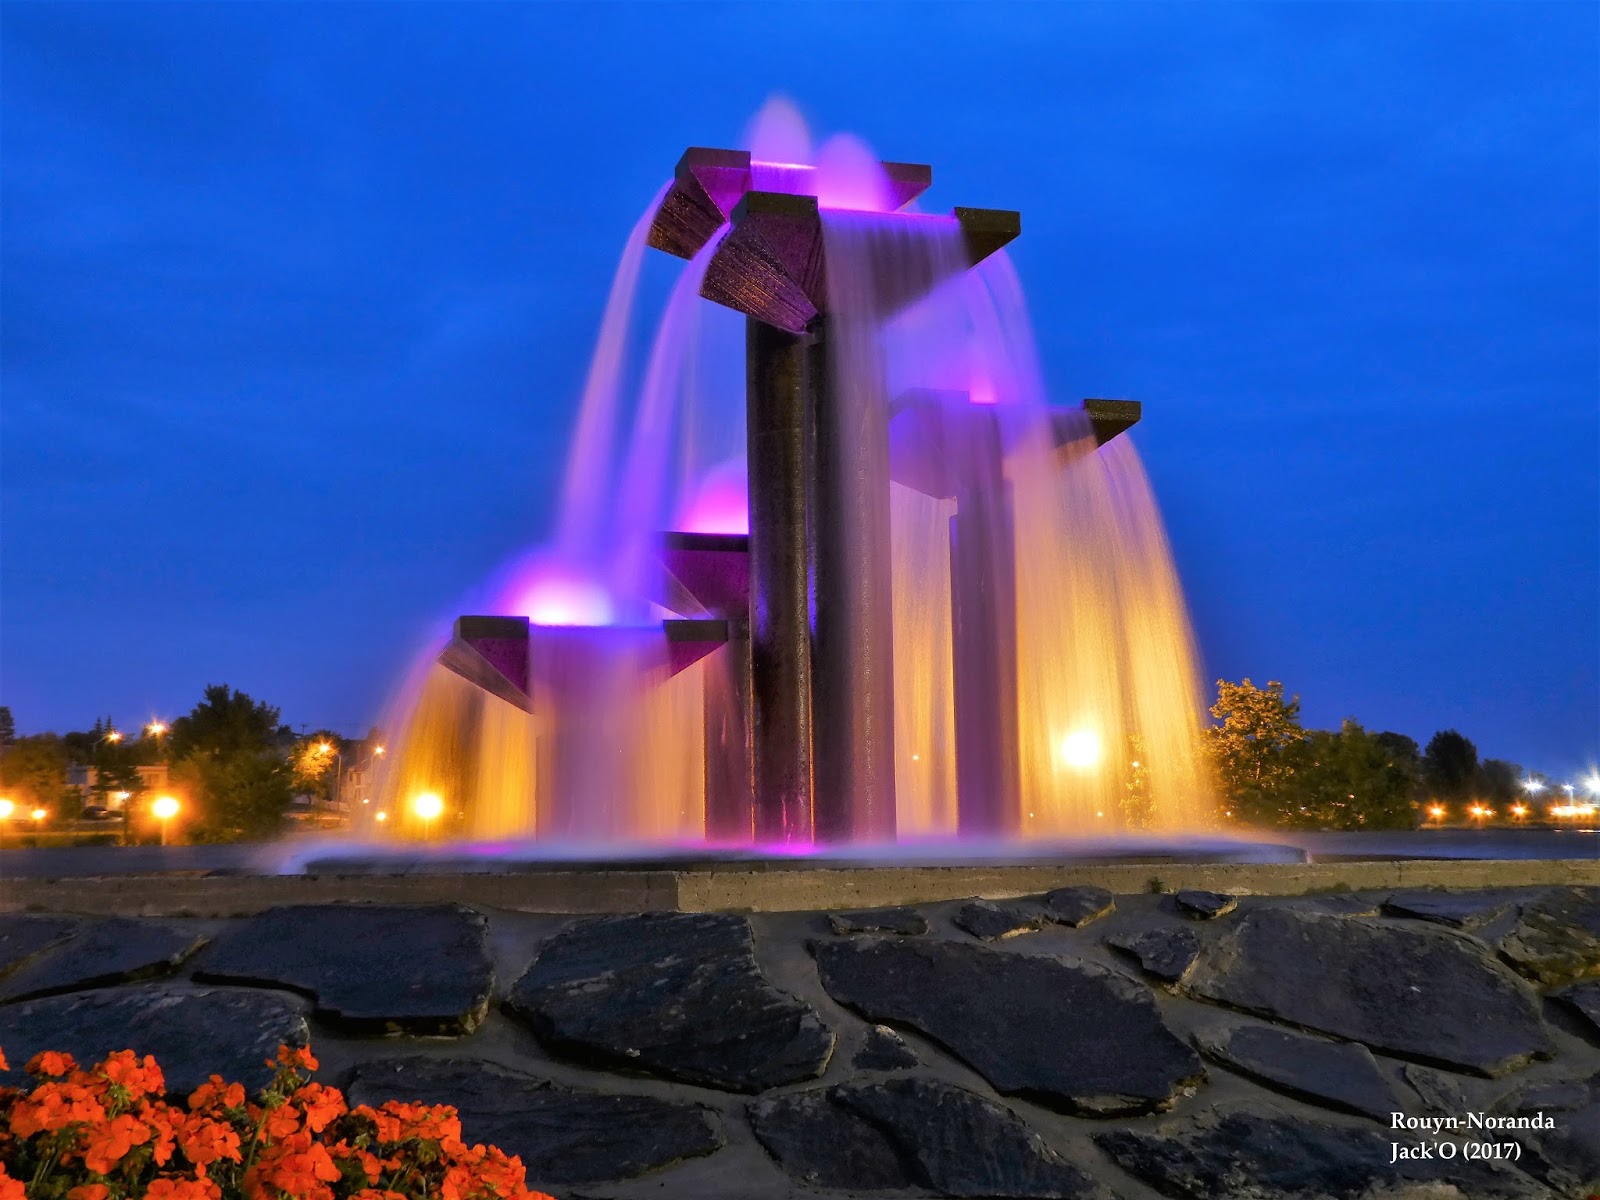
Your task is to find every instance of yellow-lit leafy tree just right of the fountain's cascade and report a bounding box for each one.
[1206,678,1306,824]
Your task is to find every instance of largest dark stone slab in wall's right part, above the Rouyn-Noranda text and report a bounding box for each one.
[1187,909,1554,1077]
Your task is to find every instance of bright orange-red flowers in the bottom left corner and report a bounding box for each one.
[0,1046,552,1200]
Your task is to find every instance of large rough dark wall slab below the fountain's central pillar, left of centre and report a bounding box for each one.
[506,912,851,1091]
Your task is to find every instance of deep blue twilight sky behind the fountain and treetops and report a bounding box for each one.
[0,0,1600,771]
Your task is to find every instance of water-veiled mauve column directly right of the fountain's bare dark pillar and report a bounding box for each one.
[806,318,894,842]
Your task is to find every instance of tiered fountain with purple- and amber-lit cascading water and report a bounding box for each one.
[374,112,1211,851]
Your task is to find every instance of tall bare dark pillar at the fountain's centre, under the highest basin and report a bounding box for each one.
[746,317,813,843]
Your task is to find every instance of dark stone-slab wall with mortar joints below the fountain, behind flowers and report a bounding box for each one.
[0,886,1600,1200]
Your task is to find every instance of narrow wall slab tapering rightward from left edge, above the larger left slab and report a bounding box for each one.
[0,917,205,1002]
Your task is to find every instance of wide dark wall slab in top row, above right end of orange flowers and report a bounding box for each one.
[195,904,494,1035]
